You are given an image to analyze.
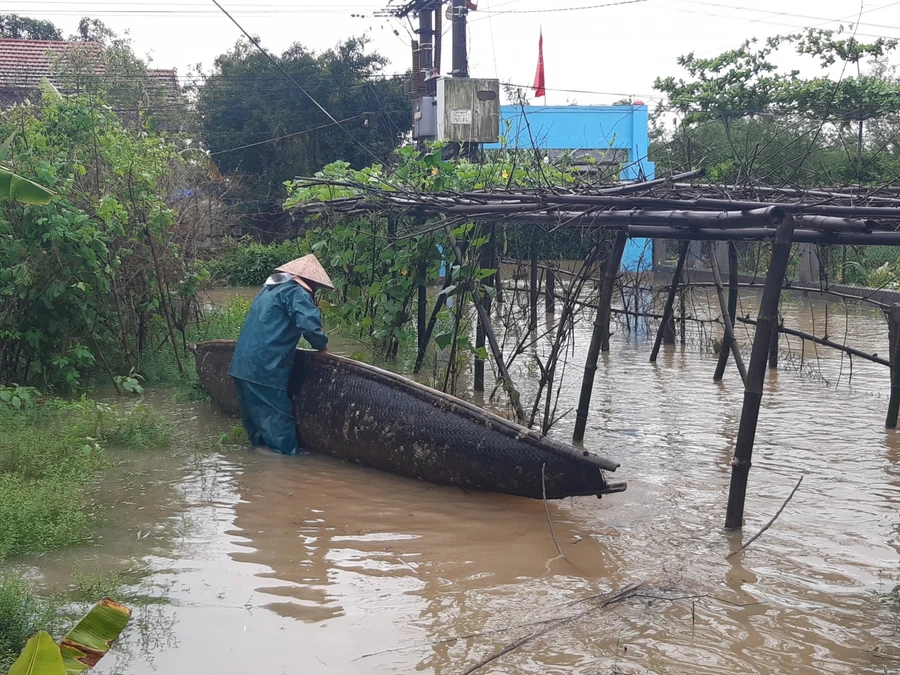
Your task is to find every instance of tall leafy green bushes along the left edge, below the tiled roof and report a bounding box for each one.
[0,89,212,386]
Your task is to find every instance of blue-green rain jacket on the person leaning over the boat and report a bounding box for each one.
[228,280,328,391]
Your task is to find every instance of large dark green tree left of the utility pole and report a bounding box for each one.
[197,37,412,198]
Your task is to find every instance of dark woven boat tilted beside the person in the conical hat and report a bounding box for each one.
[196,341,626,499]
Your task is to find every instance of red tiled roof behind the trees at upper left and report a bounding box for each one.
[0,39,184,109]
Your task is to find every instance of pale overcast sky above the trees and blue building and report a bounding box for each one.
[12,0,900,104]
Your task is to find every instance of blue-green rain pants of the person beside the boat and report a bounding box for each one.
[232,377,299,455]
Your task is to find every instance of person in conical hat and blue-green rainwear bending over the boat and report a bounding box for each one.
[228,255,334,455]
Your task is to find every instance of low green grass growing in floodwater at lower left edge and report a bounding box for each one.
[0,398,174,672]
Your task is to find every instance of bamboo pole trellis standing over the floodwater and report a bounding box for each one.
[288,172,900,528]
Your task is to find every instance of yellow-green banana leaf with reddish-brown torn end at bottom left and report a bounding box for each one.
[60,598,131,675]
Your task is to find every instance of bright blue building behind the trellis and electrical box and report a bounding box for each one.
[485,104,655,271]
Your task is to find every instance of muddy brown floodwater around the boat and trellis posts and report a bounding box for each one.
[17,286,900,675]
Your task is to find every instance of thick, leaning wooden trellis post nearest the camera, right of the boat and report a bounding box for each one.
[725,214,794,529]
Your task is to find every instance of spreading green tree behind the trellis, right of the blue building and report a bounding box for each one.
[653,30,900,186]
